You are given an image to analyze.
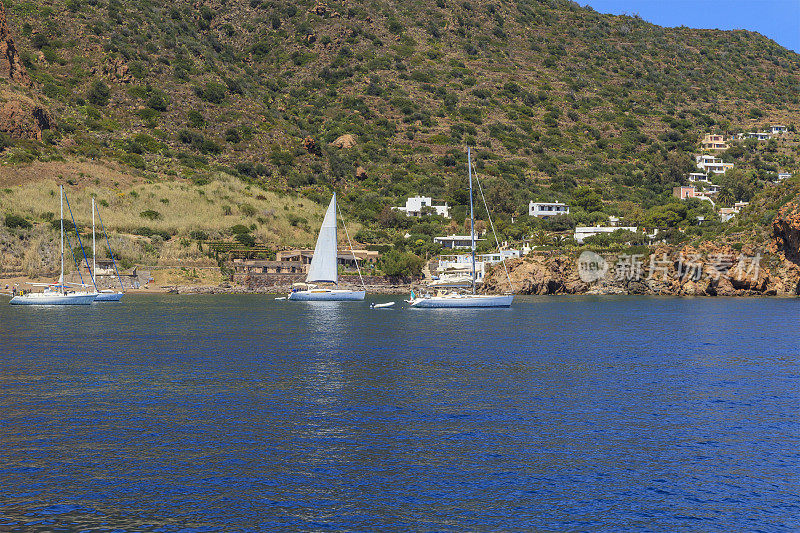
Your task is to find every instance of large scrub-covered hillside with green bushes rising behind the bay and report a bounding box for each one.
[0,0,800,274]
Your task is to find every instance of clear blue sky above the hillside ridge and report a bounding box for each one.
[578,0,800,52]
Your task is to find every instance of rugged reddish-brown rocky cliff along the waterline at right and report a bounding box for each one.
[483,242,800,296]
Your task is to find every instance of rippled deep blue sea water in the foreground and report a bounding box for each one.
[0,295,800,532]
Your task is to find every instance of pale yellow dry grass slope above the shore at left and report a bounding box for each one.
[0,174,324,246]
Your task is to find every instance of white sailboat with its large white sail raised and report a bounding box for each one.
[287,193,367,302]
